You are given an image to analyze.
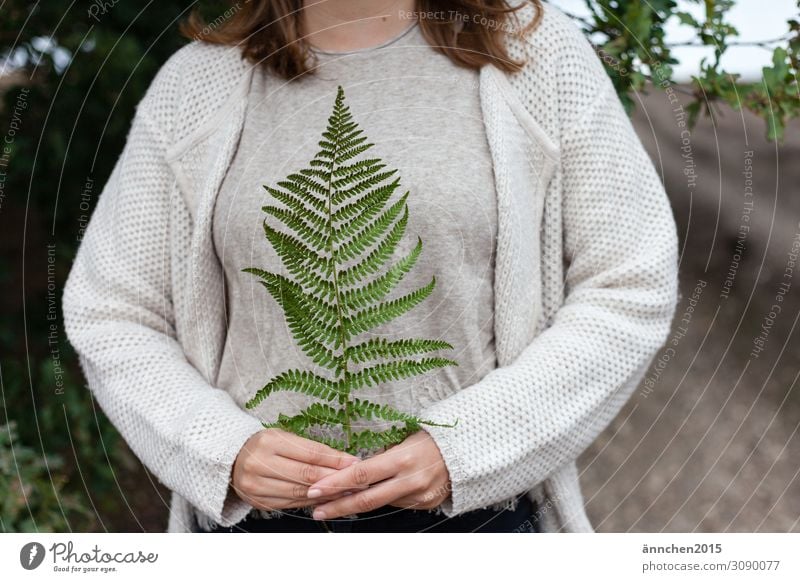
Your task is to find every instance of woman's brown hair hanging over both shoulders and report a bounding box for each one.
[180,0,542,79]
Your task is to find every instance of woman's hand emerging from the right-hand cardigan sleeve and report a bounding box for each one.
[309,430,450,519]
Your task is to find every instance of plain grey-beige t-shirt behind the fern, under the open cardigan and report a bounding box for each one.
[213,23,497,444]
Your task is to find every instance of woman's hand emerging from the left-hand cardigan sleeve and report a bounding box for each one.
[231,428,360,509]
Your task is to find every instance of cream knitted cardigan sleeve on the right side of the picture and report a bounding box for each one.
[420,70,678,516]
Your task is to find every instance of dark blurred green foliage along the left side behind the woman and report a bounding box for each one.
[0,0,219,531]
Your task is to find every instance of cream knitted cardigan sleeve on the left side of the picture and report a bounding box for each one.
[62,91,263,525]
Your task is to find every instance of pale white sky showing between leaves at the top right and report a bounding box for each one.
[549,0,797,81]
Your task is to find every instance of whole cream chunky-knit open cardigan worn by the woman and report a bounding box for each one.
[63,5,678,532]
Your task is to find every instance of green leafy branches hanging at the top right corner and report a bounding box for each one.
[575,0,800,141]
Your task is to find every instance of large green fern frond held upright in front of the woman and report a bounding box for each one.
[242,87,458,453]
